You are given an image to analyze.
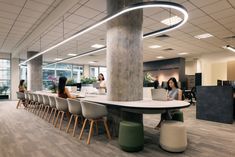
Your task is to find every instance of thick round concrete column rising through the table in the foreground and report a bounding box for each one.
[106,0,143,101]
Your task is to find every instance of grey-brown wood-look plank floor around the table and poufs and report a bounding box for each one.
[0,101,235,157]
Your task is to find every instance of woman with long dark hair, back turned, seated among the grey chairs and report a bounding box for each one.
[58,77,76,99]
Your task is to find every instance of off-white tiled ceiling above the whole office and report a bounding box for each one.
[0,0,235,65]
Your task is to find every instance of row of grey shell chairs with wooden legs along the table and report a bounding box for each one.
[16,92,111,144]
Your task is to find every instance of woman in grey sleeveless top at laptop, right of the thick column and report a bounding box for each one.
[155,77,182,129]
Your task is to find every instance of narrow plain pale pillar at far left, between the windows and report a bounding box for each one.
[11,58,20,100]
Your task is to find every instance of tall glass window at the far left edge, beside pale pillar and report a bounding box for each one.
[0,59,11,99]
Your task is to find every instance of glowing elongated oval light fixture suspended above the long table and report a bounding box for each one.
[19,1,188,66]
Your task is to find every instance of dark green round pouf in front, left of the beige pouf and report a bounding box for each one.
[118,121,144,152]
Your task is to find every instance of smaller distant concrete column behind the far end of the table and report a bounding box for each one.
[27,51,42,91]
